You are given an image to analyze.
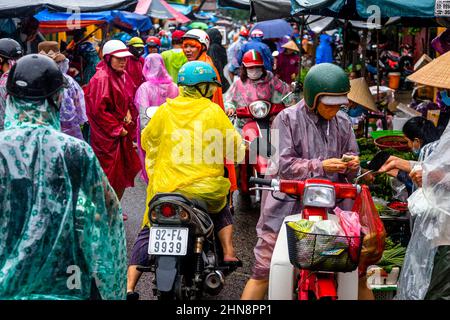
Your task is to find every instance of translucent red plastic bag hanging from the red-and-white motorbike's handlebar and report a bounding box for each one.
[352,185,386,273]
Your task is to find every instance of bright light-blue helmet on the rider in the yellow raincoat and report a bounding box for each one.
[178,61,222,86]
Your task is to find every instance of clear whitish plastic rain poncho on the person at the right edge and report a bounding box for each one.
[396,120,450,300]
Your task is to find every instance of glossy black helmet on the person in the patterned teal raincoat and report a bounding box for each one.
[6,54,67,100]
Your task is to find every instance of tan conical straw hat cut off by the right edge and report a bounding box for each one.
[408,51,450,89]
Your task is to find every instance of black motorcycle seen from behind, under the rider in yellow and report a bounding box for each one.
[137,193,239,300]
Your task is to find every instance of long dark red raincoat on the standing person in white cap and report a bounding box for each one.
[85,60,141,192]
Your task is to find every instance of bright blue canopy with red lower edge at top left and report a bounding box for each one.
[34,10,152,33]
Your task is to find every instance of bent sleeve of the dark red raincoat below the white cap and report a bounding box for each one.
[86,78,123,137]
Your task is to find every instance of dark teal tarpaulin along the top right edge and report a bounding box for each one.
[291,0,442,18]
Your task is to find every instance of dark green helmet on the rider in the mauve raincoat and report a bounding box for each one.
[303,63,350,110]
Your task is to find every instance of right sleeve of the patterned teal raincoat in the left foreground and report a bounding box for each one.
[78,152,127,300]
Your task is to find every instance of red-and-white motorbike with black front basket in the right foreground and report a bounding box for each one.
[250,152,388,300]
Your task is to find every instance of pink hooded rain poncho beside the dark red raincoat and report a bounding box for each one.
[134,53,178,183]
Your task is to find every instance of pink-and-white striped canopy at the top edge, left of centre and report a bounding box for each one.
[134,0,191,23]
